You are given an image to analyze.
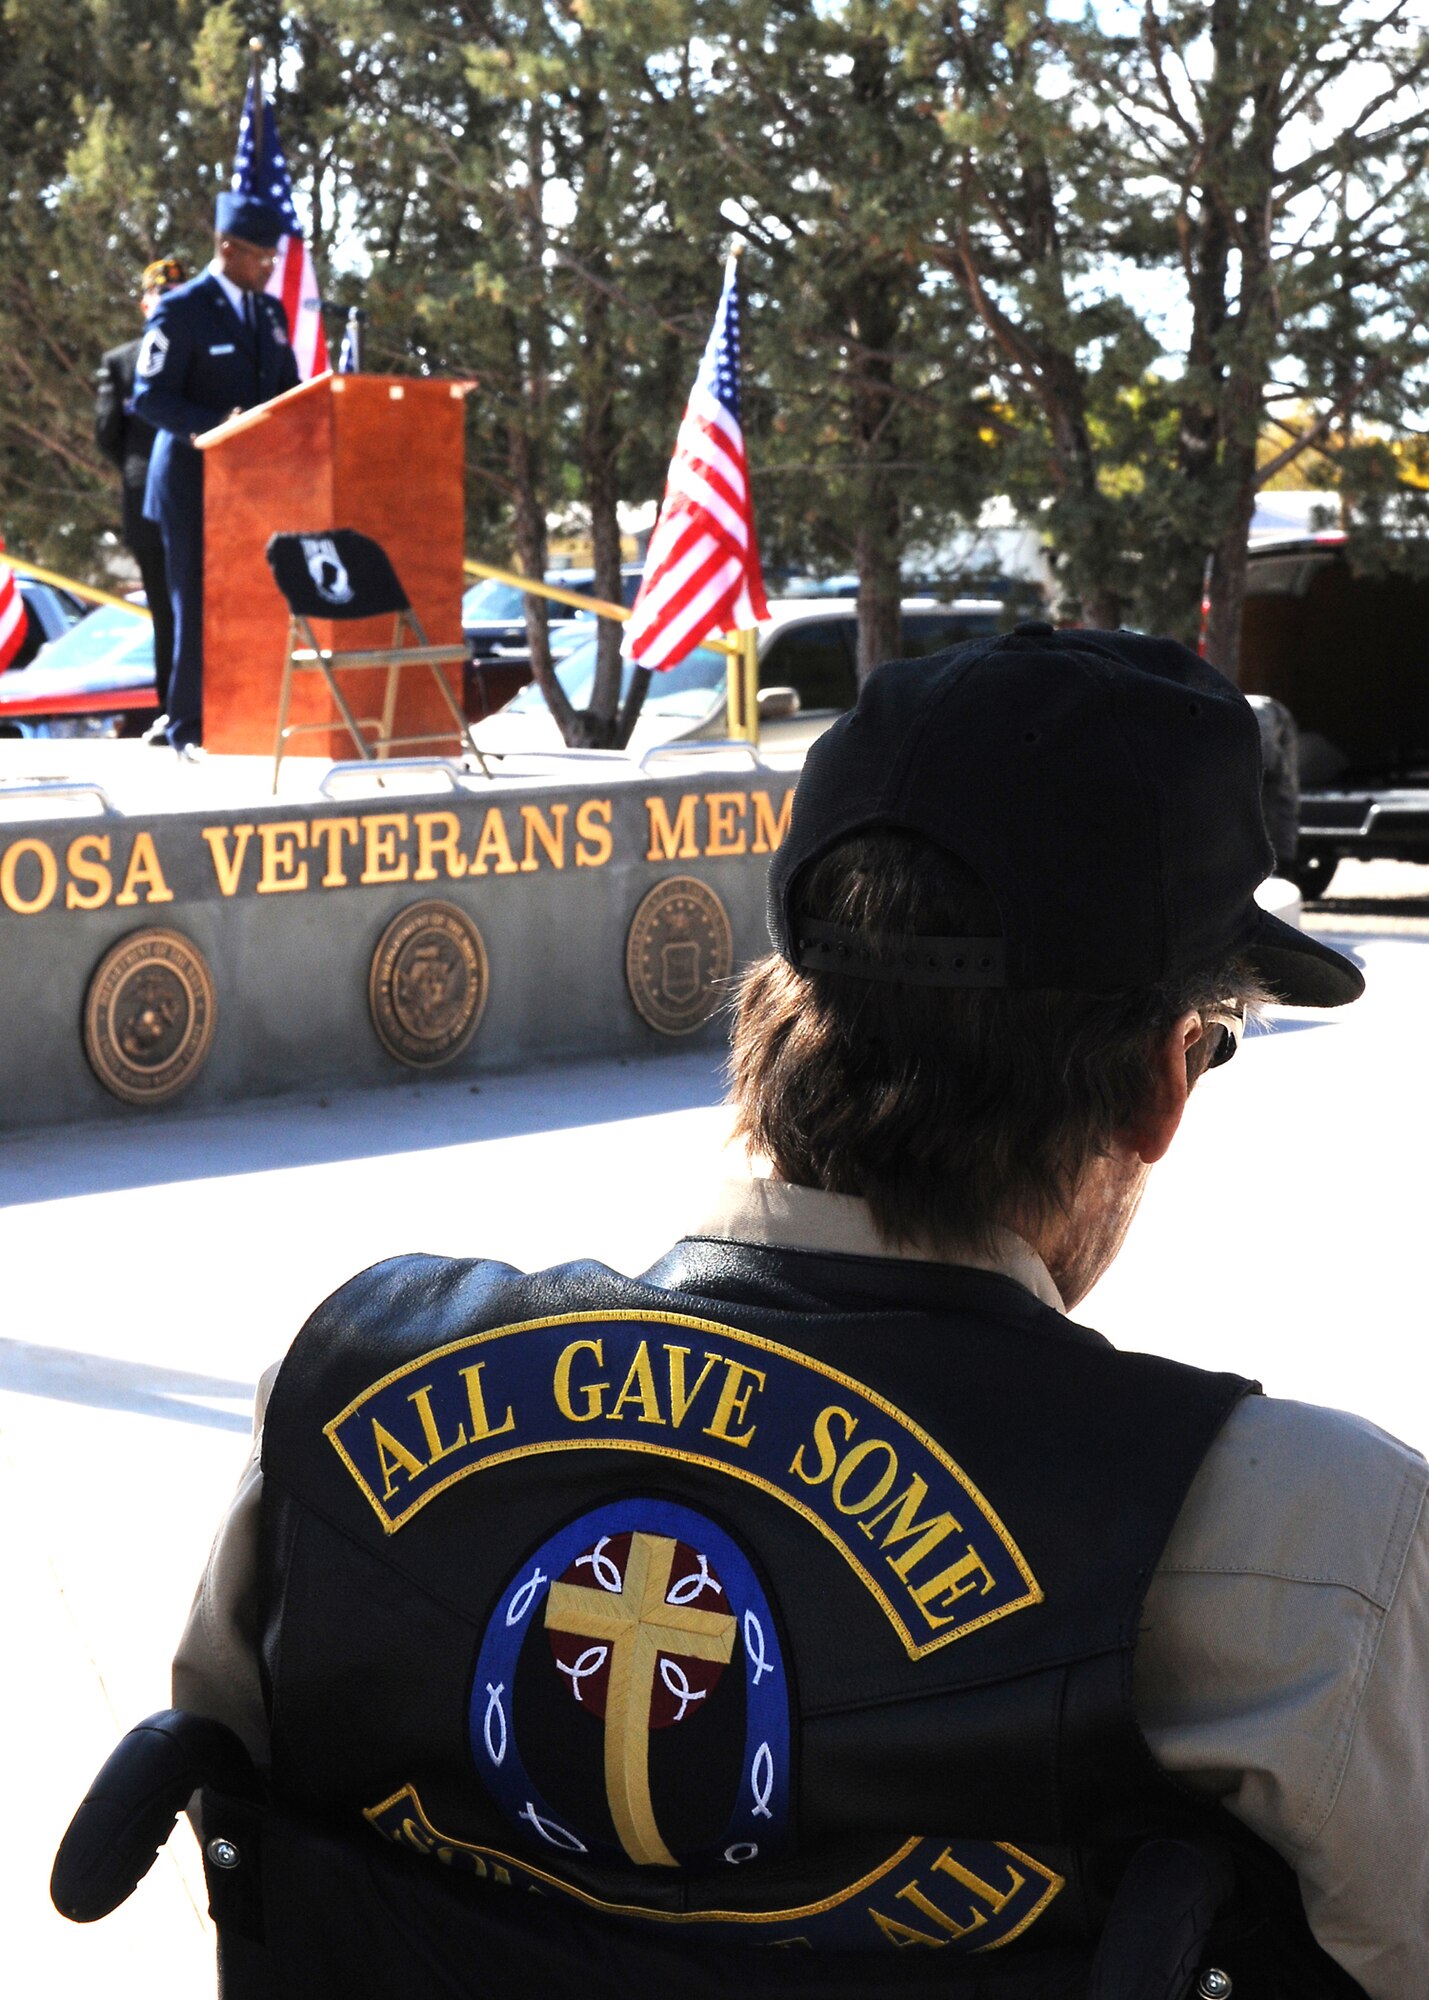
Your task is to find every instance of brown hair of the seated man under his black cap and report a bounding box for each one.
[731,832,1263,1250]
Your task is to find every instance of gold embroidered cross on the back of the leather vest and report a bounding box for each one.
[546,1534,737,1868]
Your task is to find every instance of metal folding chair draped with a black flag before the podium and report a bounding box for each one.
[268,528,490,792]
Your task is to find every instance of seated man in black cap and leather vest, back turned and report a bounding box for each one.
[122,624,1429,2000]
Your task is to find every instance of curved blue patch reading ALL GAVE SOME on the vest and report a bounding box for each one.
[326,1312,1043,1660]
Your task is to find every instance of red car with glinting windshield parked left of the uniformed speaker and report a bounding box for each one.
[0,604,158,736]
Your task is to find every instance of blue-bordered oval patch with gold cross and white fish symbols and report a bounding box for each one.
[470,1500,791,1870]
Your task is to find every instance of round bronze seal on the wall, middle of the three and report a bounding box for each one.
[368,902,488,1070]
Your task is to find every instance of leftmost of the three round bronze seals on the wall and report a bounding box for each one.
[84,926,218,1104]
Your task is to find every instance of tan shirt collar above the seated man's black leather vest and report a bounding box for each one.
[686,1174,1067,1312]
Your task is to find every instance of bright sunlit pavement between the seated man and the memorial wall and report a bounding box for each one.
[0,864,1429,2000]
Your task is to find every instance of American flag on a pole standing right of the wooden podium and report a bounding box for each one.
[624,258,769,668]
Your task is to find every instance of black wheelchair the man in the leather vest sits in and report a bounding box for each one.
[50,1710,1240,2000]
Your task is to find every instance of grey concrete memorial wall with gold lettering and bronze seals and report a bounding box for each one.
[0,760,795,1130]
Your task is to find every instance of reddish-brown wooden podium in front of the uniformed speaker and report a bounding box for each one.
[198,374,474,758]
